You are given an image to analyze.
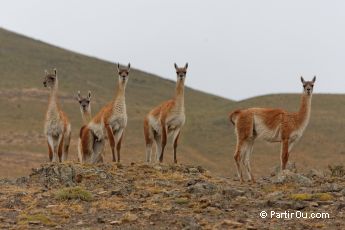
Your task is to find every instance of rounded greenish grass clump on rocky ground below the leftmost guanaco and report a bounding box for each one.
[55,187,93,201]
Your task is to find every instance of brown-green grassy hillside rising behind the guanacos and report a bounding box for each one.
[0,29,345,177]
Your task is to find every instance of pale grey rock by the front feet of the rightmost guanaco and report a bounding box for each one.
[271,170,313,187]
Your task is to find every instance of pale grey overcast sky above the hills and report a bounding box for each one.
[0,0,345,99]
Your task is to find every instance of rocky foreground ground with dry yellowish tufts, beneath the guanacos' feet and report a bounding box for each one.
[0,163,345,229]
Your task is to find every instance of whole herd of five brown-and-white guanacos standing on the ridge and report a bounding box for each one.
[43,63,316,182]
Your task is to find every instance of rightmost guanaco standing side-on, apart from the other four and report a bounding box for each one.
[229,77,316,182]
